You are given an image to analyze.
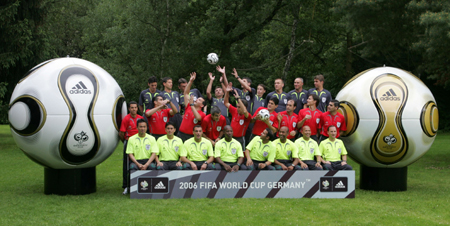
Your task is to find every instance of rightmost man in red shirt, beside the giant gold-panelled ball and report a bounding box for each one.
[319,100,347,143]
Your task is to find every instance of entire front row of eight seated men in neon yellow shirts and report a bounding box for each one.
[126,119,352,172]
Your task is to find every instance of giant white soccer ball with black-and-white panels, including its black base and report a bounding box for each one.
[9,58,126,194]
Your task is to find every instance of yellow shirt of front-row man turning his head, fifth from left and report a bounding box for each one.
[246,136,275,162]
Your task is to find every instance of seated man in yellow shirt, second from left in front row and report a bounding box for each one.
[156,121,183,170]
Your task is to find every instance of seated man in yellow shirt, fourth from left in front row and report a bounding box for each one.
[214,125,244,172]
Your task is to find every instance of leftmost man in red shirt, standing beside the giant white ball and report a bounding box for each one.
[119,101,144,195]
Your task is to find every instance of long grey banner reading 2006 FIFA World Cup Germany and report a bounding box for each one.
[130,170,355,199]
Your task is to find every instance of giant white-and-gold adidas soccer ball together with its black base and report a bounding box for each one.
[336,67,439,191]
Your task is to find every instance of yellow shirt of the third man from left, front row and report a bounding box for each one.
[180,137,214,161]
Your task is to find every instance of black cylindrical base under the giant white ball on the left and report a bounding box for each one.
[44,166,97,195]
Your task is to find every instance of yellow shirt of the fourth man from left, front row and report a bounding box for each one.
[214,138,244,162]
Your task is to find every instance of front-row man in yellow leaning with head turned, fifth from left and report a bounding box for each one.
[241,128,276,170]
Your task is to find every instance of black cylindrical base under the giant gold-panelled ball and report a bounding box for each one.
[359,165,408,191]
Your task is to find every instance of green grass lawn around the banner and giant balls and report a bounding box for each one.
[0,125,450,225]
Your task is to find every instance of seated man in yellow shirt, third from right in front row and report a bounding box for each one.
[273,126,302,171]
